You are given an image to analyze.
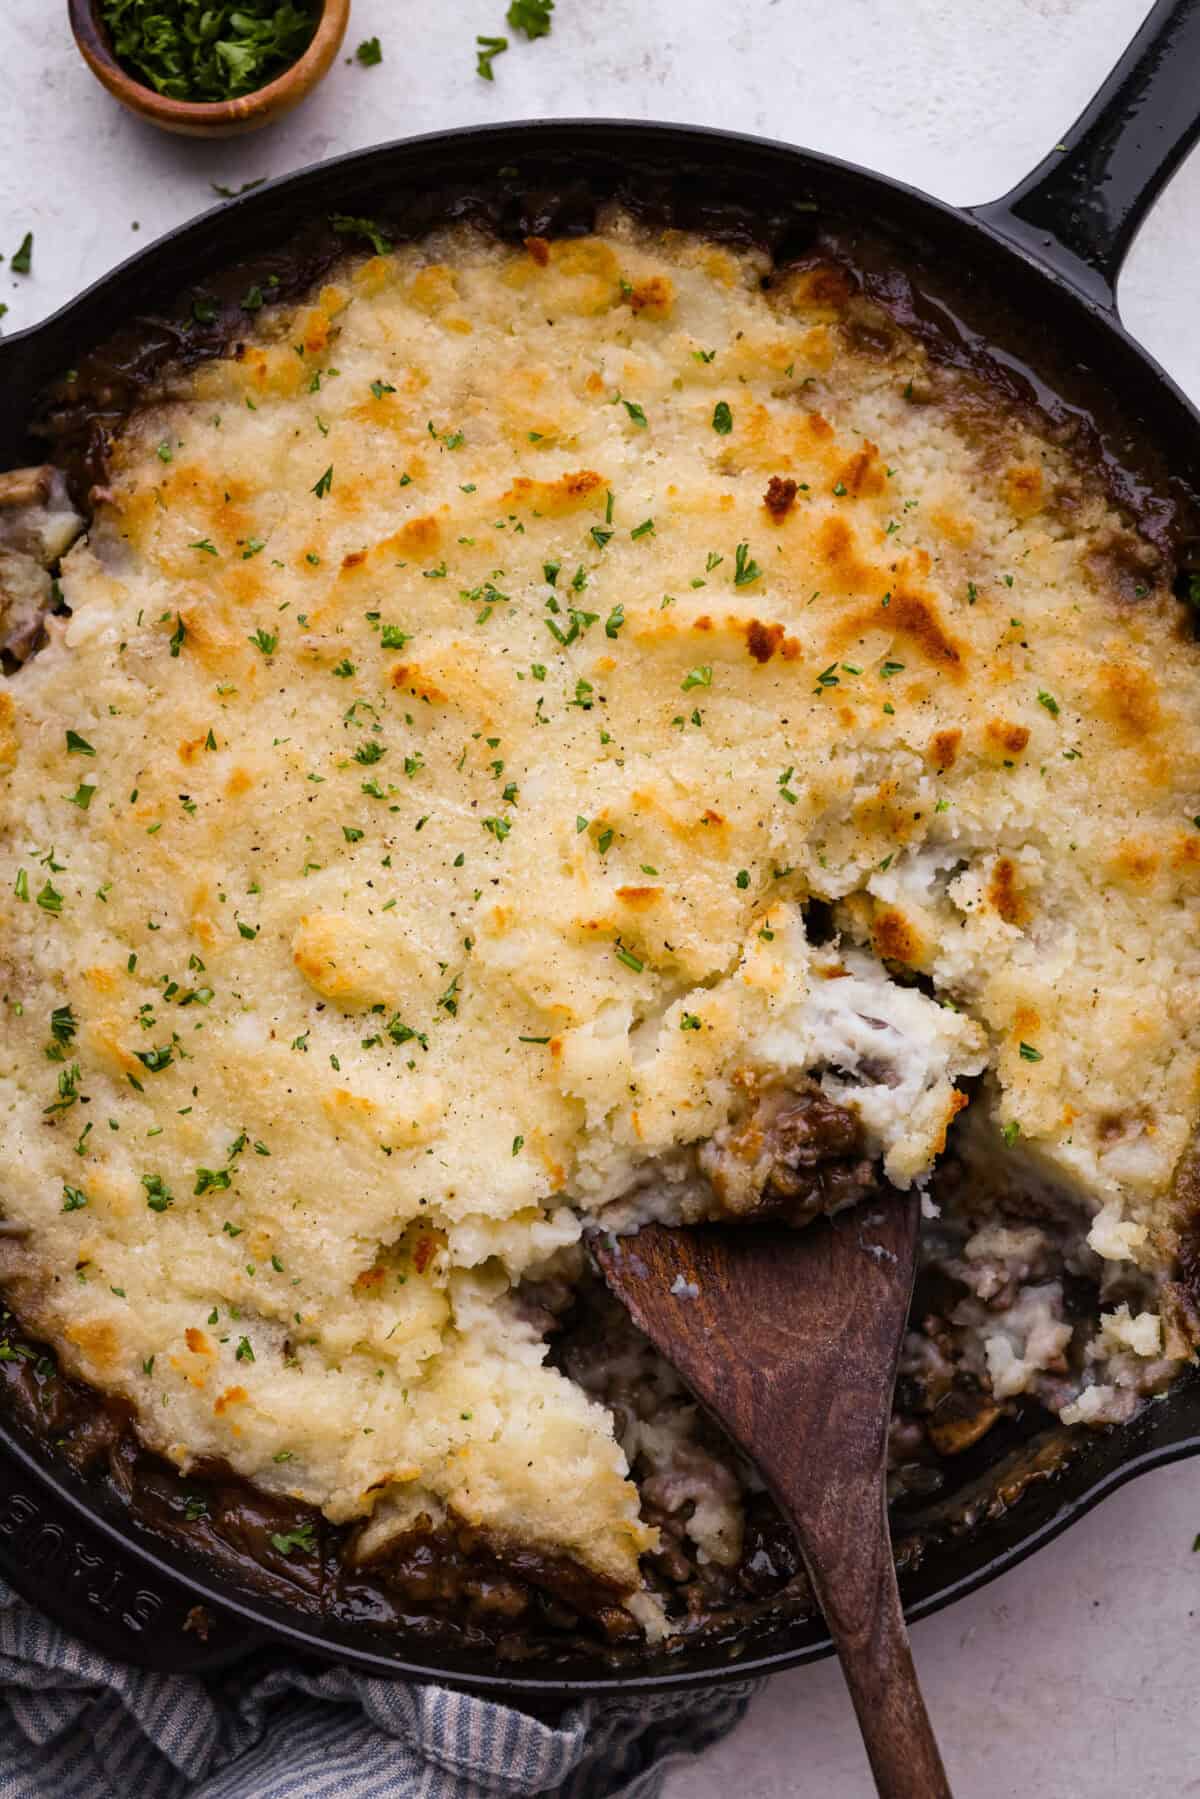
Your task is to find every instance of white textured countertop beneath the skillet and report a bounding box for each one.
[0,0,1200,1799]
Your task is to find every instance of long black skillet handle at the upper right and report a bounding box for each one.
[972,0,1200,311]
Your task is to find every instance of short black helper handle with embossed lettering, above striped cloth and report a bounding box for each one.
[0,1437,263,1675]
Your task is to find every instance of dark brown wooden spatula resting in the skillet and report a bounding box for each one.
[590,1193,952,1799]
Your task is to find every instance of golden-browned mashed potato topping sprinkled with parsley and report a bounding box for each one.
[0,218,1200,1590]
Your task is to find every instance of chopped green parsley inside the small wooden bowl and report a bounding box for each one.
[97,0,320,103]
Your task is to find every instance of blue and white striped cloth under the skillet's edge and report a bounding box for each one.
[0,1585,754,1799]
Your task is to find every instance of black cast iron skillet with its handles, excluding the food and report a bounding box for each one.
[0,0,1200,1704]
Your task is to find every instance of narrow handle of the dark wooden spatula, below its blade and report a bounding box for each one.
[779,1481,952,1799]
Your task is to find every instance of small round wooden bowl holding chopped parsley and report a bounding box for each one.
[70,0,351,137]
